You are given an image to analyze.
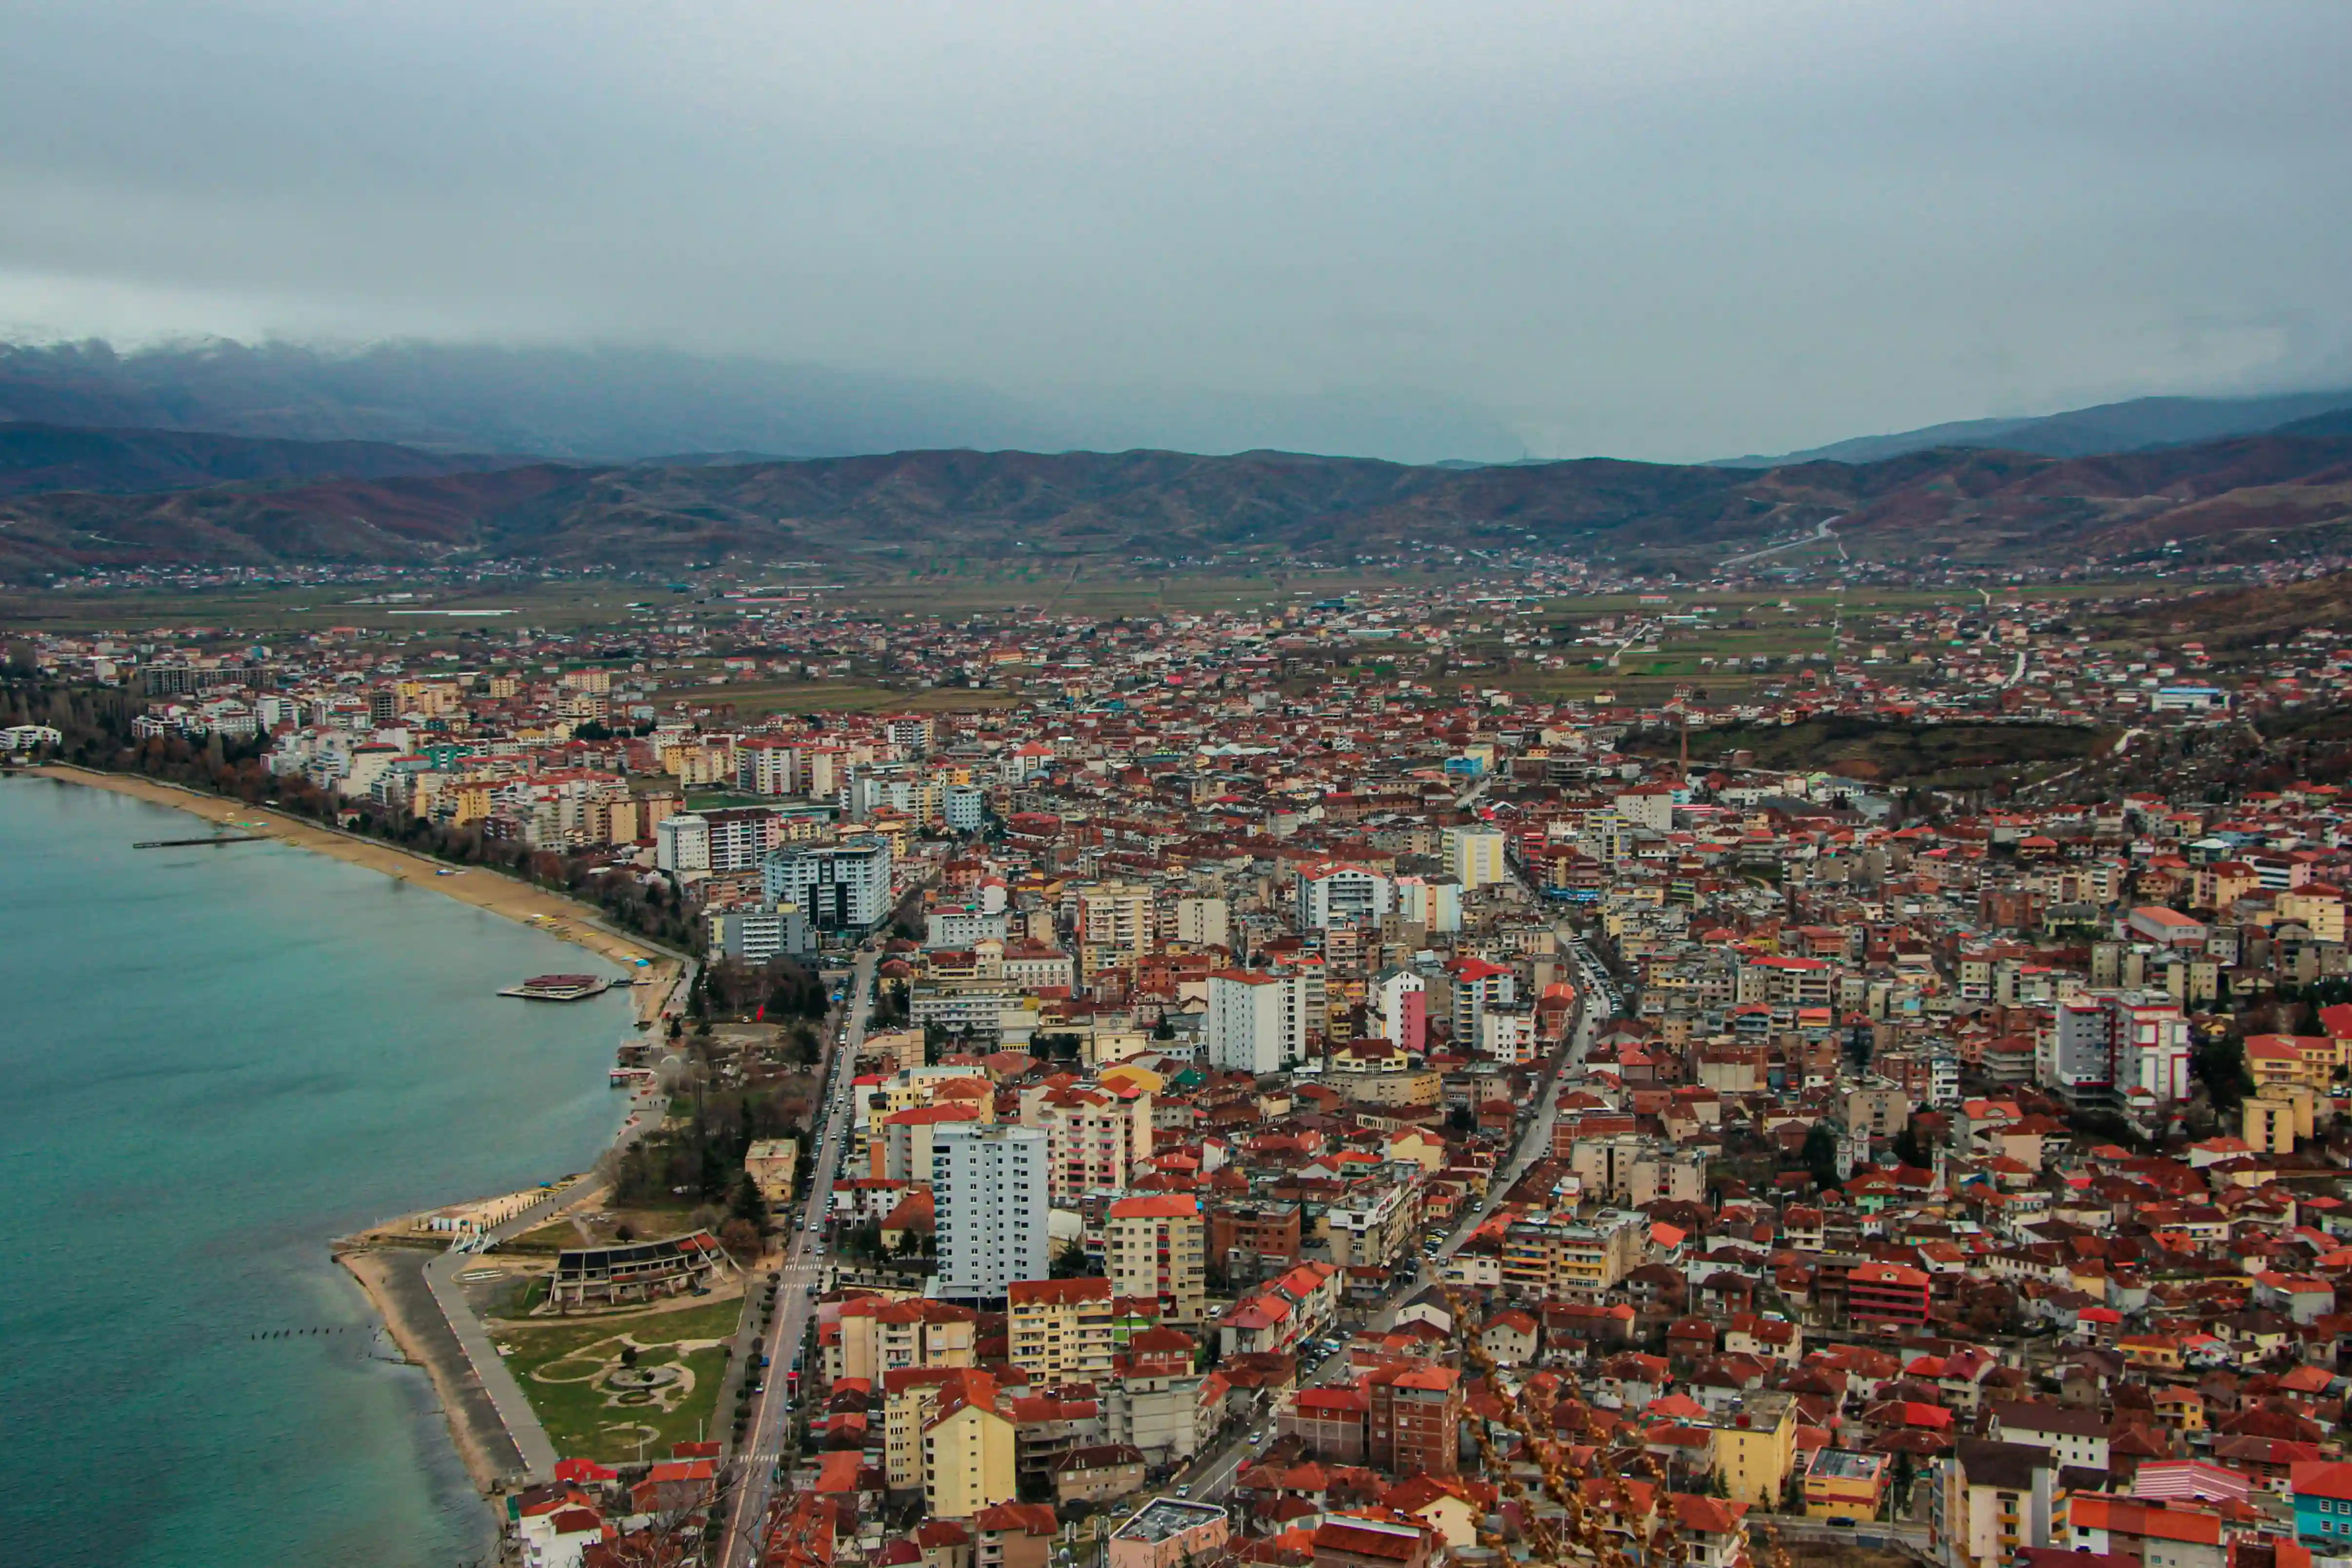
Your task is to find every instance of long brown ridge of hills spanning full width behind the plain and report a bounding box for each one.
[0,435,2352,581]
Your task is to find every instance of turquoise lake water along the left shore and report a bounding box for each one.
[0,778,628,1568]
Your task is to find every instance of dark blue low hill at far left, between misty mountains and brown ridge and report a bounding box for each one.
[0,423,510,496]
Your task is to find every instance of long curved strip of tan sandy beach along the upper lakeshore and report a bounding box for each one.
[26,764,685,1022]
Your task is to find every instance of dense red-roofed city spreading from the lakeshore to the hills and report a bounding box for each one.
[5,557,2352,1568]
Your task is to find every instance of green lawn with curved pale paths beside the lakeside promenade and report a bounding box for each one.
[492,1298,743,1465]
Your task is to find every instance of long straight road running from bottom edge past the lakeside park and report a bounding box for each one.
[717,950,875,1568]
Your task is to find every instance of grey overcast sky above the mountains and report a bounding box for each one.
[0,0,2352,458]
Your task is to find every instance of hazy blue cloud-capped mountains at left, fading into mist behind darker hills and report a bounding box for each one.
[0,341,1527,463]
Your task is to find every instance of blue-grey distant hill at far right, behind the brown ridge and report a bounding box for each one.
[1717,388,2352,468]
